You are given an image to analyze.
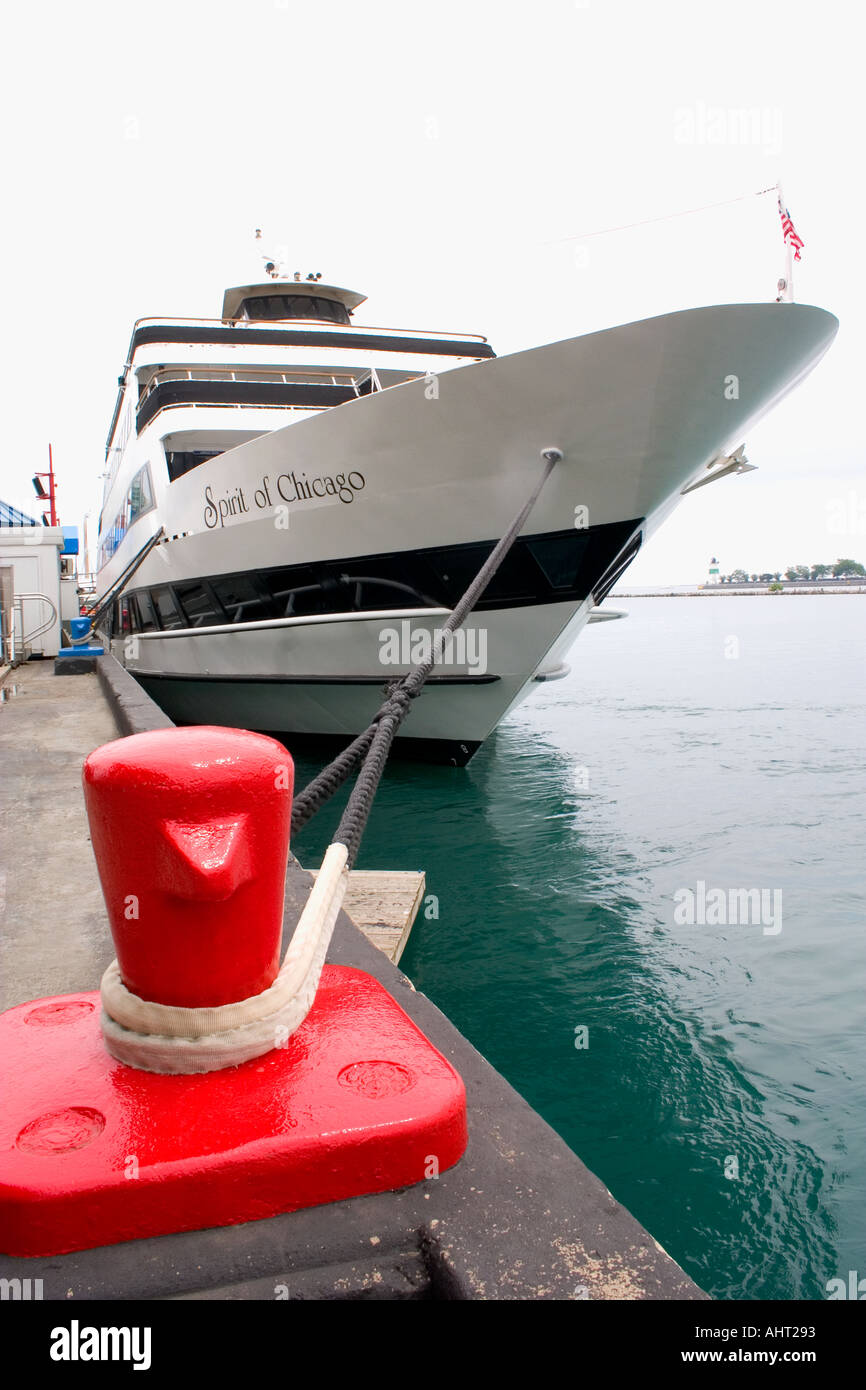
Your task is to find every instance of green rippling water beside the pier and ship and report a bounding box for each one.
[295,596,866,1300]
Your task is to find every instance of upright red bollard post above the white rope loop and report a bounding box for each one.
[83,727,293,1008]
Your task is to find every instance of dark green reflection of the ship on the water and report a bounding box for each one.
[295,723,837,1298]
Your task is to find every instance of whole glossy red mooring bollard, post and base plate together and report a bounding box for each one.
[0,727,466,1257]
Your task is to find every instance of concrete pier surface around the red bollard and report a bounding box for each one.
[0,657,706,1302]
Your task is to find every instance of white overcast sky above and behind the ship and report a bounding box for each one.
[0,0,866,584]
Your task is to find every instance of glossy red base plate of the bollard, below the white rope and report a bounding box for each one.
[0,966,466,1257]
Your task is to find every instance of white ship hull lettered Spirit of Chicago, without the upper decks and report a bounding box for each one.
[100,304,838,762]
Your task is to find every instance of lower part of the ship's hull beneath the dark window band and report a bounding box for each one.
[128,600,589,765]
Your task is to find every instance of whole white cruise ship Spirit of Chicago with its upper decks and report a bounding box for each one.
[97,261,838,766]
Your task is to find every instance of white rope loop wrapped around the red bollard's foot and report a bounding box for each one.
[101,842,349,1073]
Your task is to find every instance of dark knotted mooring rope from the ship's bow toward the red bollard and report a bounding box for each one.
[292,449,562,869]
